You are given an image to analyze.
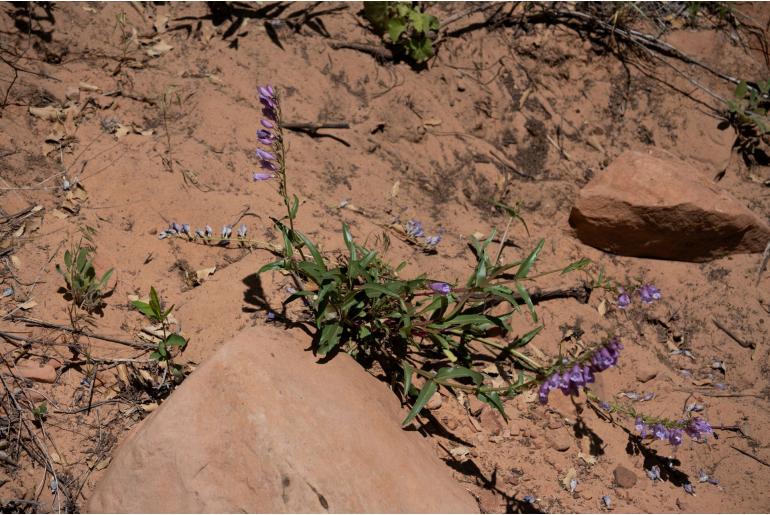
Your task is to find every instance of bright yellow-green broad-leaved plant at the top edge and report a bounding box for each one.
[363,2,439,64]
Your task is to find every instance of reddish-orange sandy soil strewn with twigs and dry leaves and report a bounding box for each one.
[0,3,770,512]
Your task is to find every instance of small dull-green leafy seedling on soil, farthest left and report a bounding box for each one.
[56,245,113,313]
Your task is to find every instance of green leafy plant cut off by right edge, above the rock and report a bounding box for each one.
[723,80,770,165]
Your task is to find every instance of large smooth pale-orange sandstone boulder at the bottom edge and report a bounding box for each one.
[88,327,478,513]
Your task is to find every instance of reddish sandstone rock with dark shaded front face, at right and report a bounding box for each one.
[570,151,770,261]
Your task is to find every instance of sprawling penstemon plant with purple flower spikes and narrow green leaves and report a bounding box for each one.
[158,86,712,462]
